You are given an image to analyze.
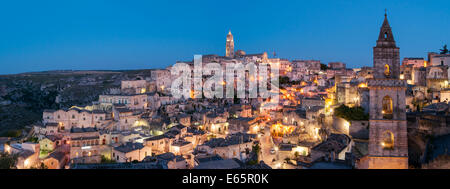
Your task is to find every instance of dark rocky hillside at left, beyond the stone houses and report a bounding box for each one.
[0,70,151,137]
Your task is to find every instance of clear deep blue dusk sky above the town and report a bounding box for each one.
[0,0,450,74]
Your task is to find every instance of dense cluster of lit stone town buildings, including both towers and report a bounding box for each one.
[6,16,450,169]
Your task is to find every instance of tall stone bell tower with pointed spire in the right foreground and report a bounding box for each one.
[361,14,408,169]
